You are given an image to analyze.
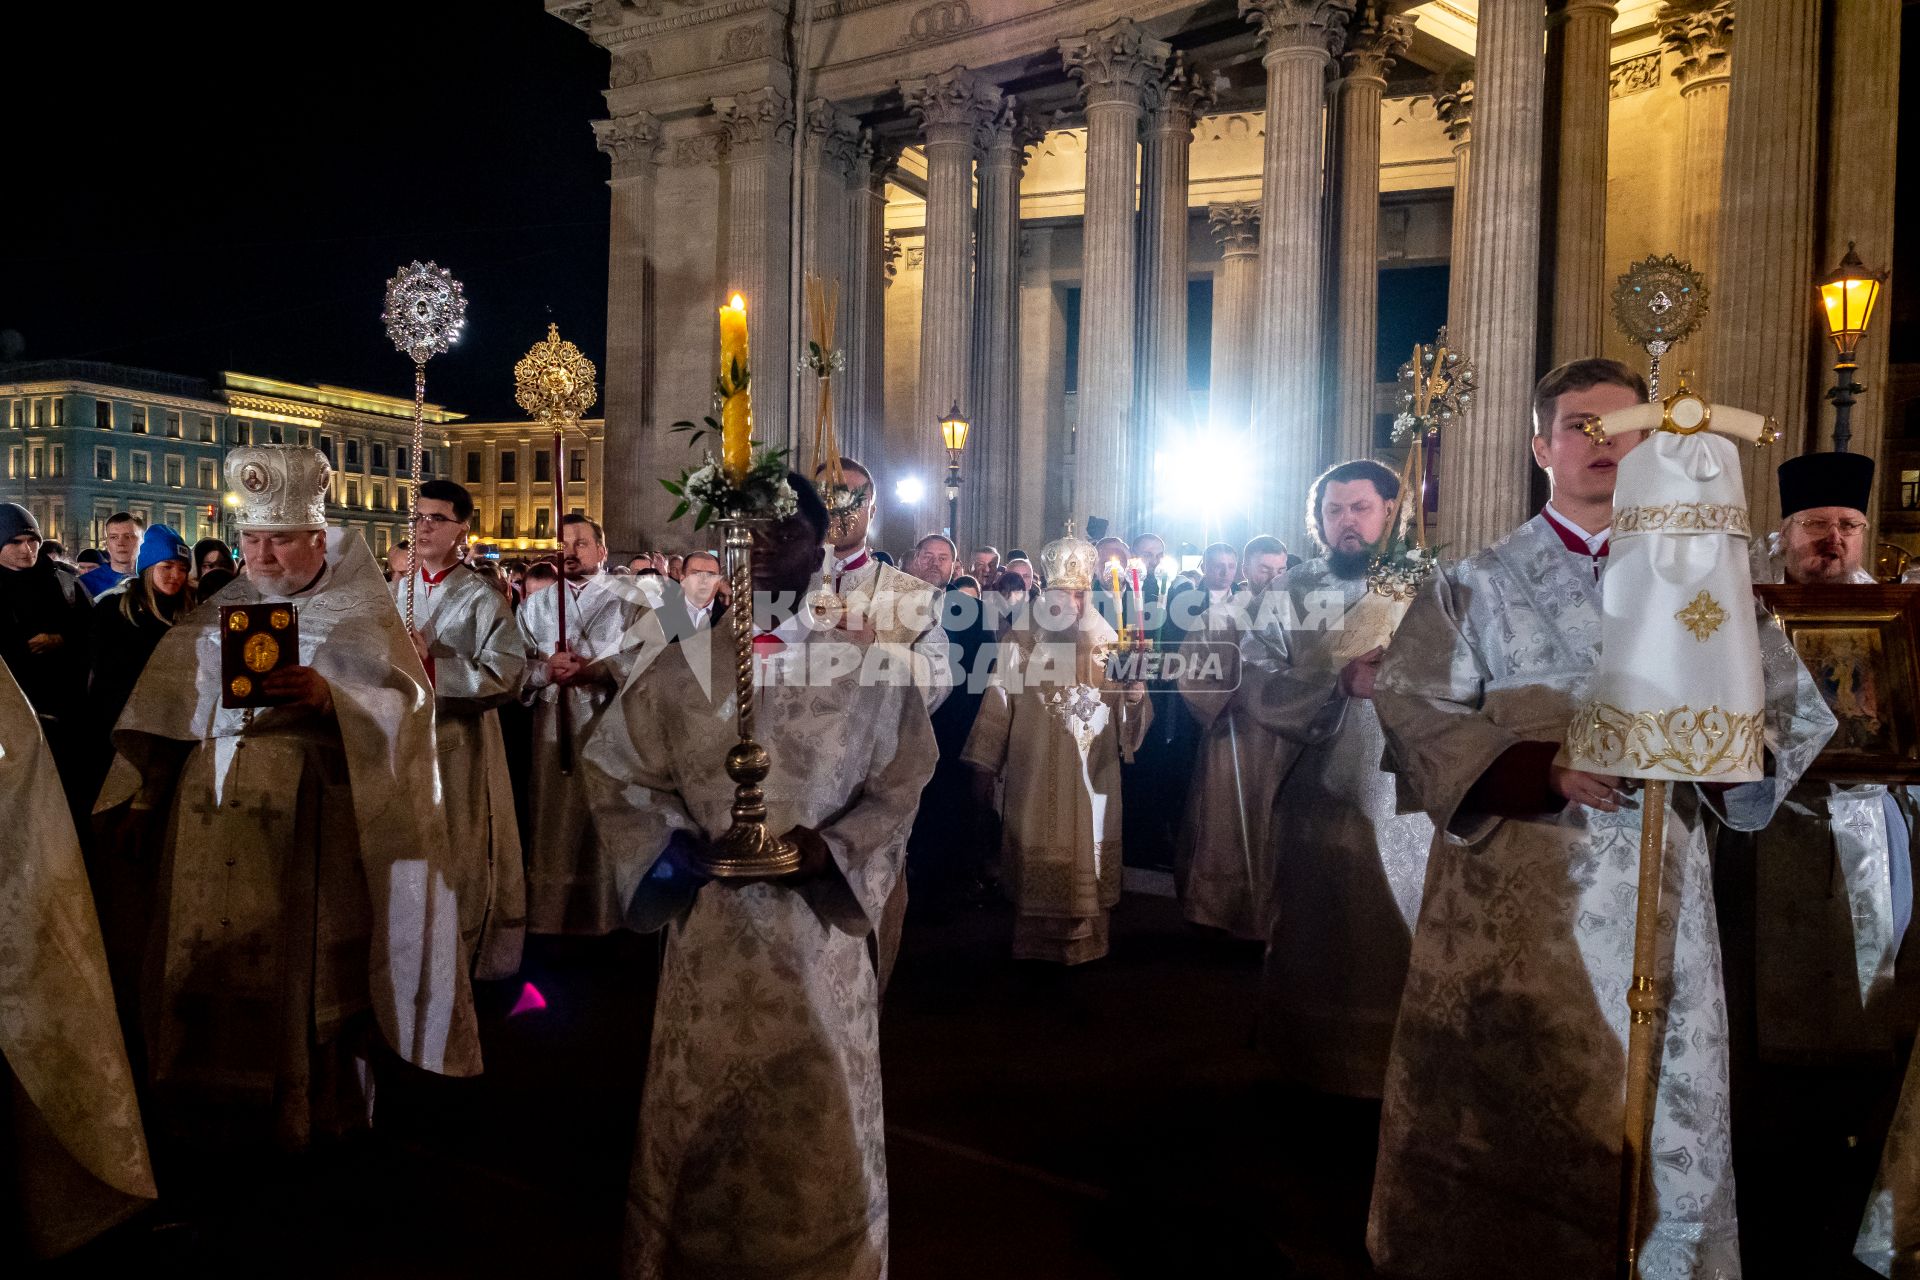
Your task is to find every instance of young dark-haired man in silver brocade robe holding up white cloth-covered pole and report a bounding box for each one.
[1367,359,1834,1280]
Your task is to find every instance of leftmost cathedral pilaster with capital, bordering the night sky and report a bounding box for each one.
[587,111,664,551]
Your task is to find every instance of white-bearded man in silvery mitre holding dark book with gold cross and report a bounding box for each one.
[100,445,480,1148]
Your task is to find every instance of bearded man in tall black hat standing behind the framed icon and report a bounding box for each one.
[1715,453,1920,1274]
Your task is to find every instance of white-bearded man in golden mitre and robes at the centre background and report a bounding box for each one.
[960,532,1154,965]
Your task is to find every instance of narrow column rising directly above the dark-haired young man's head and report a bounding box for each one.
[1544,0,1617,365]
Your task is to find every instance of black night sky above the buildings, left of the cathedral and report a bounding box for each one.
[0,0,607,418]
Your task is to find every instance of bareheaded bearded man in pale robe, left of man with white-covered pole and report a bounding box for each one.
[1240,459,1434,1098]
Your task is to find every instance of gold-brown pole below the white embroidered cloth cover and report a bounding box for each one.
[1620,779,1667,1280]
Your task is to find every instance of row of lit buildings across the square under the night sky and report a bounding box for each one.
[0,361,605,557]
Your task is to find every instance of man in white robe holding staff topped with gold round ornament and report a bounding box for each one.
[520,514,664,936]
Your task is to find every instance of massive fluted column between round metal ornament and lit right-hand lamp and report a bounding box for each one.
[1703,0,1820,532]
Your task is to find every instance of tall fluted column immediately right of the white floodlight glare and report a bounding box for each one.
[1240,0,1354,543]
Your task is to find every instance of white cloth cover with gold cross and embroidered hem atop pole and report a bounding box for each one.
[1561,384,1772,783]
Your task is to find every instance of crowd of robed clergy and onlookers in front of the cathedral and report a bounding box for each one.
[0,359,1920,1278]
